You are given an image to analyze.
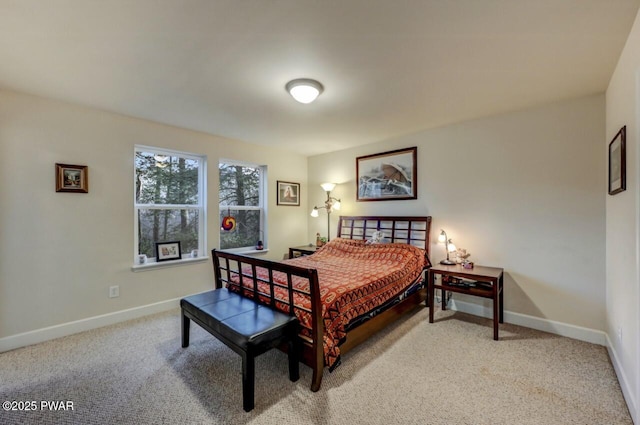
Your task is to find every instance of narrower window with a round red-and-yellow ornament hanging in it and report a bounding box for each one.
[218,160,267,251]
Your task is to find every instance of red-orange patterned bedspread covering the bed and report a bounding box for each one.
[230,238,425,370]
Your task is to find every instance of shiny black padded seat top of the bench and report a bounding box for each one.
[180,288,297,350]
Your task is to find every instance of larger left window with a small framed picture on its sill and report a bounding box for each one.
[134,146,206,264]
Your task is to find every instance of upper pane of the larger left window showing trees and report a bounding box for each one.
[135,152,200,205]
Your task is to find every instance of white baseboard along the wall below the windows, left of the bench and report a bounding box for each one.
[0,298,180,353]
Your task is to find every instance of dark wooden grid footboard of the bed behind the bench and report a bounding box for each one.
[211,249,324,392]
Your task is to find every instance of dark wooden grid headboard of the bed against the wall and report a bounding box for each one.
[338,215,431,254]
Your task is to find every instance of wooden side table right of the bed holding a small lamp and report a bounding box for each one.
[427,264,504,341]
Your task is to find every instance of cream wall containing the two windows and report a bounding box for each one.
[0,91,308,342]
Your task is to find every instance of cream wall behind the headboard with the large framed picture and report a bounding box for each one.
[308,95,605,332]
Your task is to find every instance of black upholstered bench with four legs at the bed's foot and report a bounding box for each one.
[180,288,300,412]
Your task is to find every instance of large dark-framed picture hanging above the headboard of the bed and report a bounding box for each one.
[356,147,418,201]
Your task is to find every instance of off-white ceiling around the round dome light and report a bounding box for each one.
[0,0,640,155]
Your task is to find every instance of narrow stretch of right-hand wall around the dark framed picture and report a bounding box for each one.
[601,4,640,423]
